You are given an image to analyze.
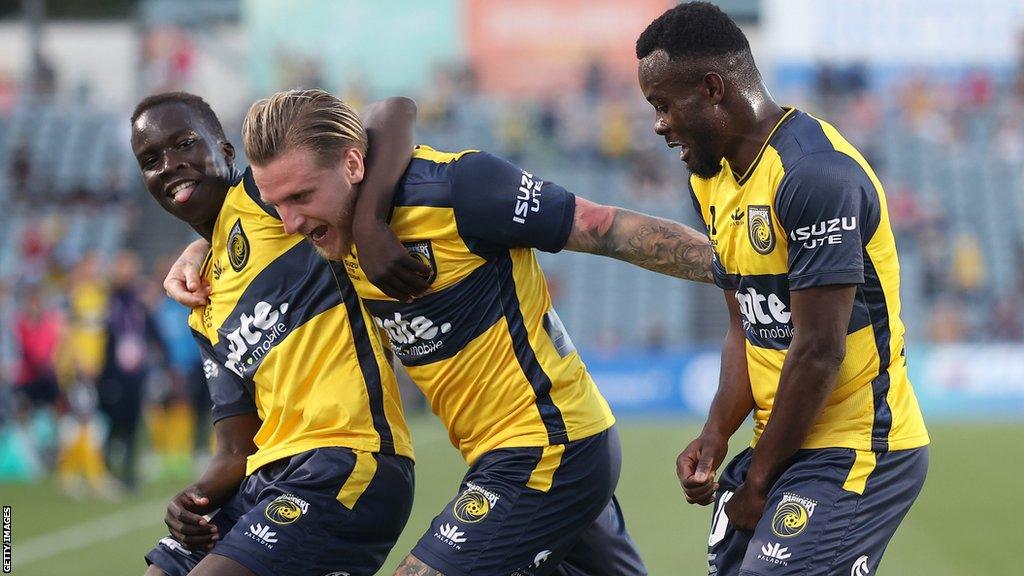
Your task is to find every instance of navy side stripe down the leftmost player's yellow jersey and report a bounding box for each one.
[331,262,395,454]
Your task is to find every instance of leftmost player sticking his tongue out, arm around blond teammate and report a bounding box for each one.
[131,92,415,576]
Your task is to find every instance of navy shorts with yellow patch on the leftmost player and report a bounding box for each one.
[145,448,413,576]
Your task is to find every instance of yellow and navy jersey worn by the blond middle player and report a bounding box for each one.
[344,146,614,463]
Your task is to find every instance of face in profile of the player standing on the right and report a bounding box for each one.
[639,50,725,178]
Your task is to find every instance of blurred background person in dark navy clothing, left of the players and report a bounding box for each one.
[98,251,166,490]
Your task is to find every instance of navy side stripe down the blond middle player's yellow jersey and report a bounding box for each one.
[488,252,568,444]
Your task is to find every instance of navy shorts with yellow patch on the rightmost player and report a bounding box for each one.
[708,446,928,576]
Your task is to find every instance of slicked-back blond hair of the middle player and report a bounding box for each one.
[242,89,367,167]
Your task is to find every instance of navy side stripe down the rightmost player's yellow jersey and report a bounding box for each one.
[857,250,893,452]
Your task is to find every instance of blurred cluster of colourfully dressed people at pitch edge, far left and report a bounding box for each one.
[0,246,209,491]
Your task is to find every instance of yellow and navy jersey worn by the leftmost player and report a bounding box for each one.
[188,166,413,474]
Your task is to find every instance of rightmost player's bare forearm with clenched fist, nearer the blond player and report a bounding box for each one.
[676,290,754,506]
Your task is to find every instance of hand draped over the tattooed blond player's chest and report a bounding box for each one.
[353,218,431,302]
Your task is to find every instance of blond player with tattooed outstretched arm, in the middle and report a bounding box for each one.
[231,90,711,576]
